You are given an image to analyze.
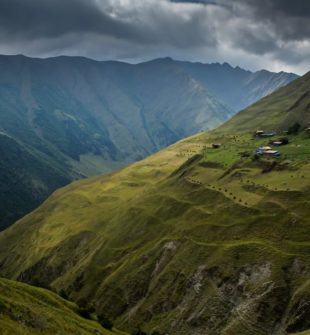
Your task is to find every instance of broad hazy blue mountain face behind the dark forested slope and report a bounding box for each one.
[0,56,232,174]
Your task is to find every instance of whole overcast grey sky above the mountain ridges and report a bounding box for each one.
[0,0,310,74]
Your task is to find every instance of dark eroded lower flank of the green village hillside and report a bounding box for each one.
[10,234,310,335]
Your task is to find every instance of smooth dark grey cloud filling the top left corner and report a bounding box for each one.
[0,0,147,39]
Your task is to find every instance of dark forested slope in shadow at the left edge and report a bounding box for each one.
[0,133,71,229]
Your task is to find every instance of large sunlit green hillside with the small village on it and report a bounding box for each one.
[0,73,310,335]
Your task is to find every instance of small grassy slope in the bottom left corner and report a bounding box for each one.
[0,279,120,335]
